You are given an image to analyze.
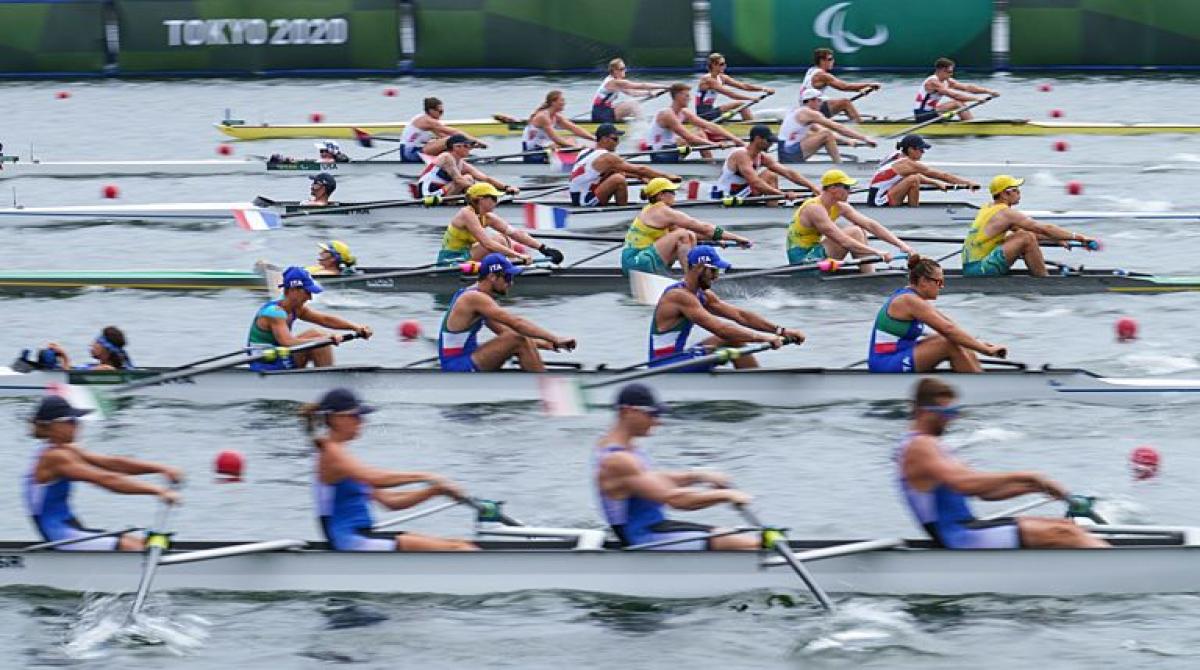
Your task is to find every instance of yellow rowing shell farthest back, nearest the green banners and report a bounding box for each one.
[215,119,1200,139]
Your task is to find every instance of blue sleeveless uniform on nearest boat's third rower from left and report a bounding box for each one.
[592,444,713,551]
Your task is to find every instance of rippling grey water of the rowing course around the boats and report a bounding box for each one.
[0,76,1200,668]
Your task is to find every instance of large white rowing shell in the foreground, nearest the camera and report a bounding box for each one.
[0,526,1200,598]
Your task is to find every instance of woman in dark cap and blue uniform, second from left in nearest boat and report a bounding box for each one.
[300,388,479,551]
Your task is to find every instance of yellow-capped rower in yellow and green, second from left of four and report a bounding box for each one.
[620,177,754,275]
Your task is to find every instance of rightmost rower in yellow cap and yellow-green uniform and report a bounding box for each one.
[962,174,1099,277]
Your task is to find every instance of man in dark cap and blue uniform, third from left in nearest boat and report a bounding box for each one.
[593,384,762,551]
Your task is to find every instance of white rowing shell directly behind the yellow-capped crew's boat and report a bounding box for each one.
[0,201,1185,231]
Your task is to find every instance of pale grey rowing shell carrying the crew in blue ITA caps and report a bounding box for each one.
[9,366,1200,408]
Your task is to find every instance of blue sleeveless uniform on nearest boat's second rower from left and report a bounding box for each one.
[313,465,400,551]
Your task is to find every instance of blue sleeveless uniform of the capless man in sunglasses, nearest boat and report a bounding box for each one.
[895,432,1021,549]
